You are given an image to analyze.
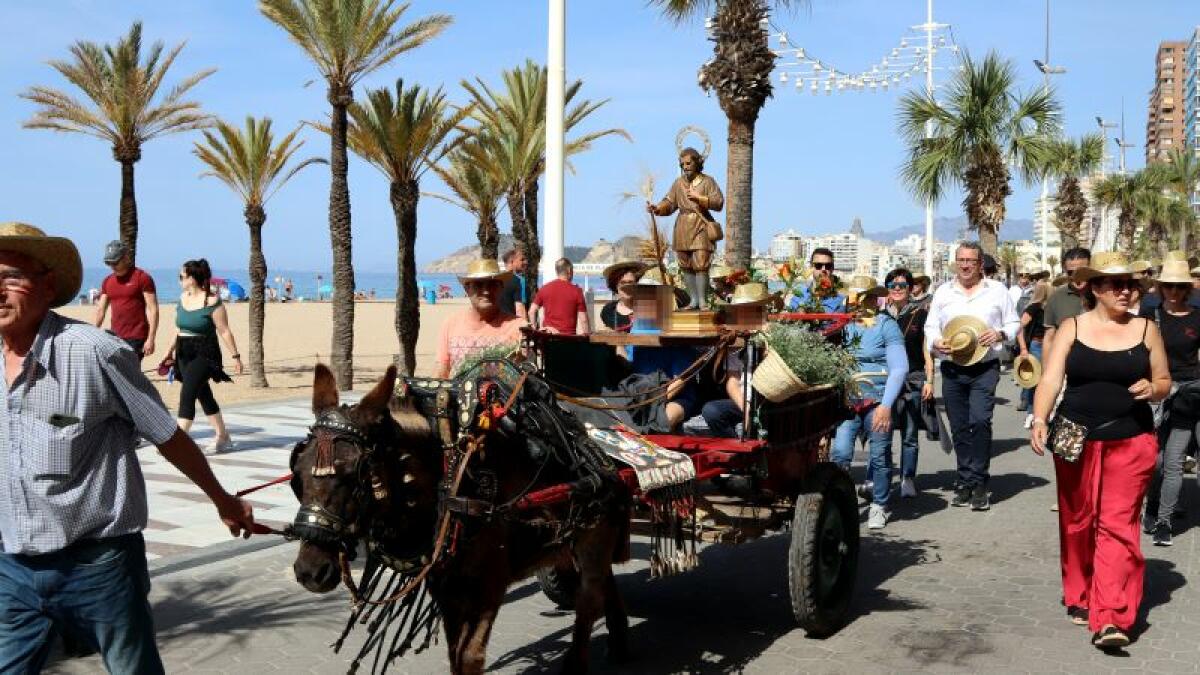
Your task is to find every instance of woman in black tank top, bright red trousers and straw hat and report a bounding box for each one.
[1030,252,1171,649]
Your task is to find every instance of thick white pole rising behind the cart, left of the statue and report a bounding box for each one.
[541,0,566,281]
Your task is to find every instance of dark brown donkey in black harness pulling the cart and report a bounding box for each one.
[292,365,629,674]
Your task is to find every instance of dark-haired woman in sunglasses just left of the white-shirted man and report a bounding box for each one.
[883,268,934,498]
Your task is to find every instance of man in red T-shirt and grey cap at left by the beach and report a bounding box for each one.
[92,241,158,359]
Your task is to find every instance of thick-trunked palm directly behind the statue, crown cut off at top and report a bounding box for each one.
[650,0,806,269]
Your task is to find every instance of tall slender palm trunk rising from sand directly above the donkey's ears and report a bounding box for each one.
[329,88,354,392]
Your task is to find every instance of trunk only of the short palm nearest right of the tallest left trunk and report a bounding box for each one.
[389,180,421,375]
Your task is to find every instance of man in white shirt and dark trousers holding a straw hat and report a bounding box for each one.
[925,241,1020,510]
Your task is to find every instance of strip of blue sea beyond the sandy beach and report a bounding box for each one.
[79,268,607,303]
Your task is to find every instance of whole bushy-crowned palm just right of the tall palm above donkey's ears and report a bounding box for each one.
[317,80,472,375]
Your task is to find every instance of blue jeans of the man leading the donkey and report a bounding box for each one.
[0,534,163,675]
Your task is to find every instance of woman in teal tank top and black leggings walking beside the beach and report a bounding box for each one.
[160,258,245,455]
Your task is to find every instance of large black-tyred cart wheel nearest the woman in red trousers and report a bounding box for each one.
[787,462,858,638]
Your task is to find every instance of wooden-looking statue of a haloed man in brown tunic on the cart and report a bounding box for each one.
[646,148,725,310]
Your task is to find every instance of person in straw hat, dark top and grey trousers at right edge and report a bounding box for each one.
[1141,261,1200,546]
